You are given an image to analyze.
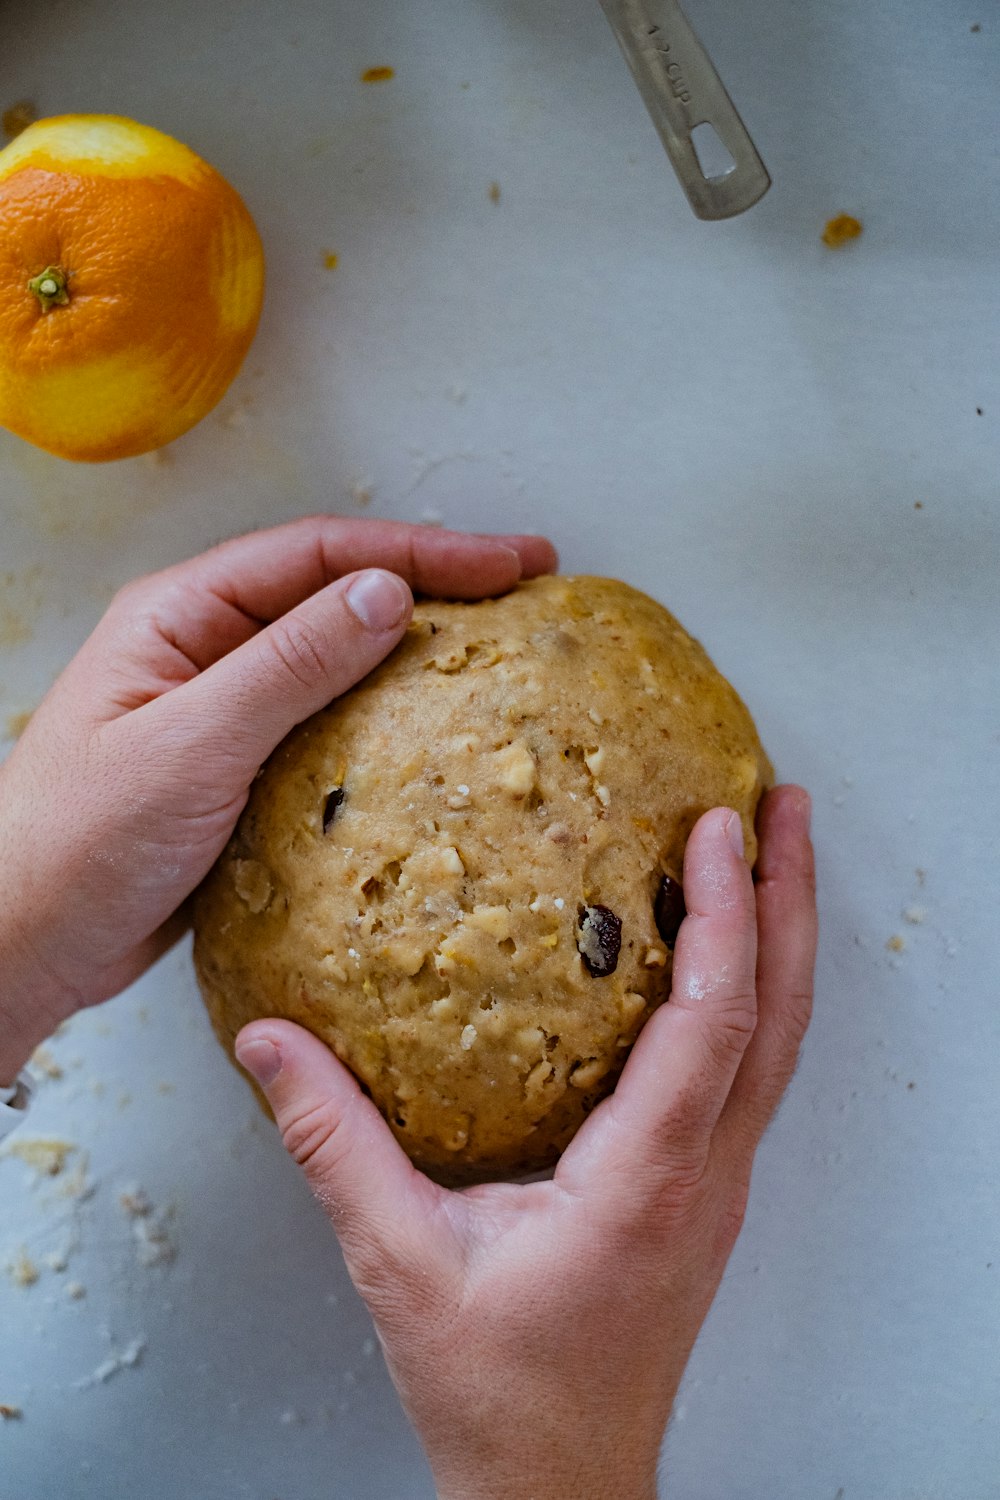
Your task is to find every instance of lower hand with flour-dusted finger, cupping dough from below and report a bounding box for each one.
[237,786,816,1500]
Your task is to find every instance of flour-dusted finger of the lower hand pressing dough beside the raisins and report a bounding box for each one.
[556,809,757,1181]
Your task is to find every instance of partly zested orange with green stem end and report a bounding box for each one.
[0,114,264,462]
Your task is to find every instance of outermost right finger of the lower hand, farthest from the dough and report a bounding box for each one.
[723,786,817,1148]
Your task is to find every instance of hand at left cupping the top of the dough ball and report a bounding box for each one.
[0,516,555,1085]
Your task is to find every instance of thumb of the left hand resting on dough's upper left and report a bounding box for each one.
[132,569,412,785]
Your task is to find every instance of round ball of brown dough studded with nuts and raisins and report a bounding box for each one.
[195,578,771,1182]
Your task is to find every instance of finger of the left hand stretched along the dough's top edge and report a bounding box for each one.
[85,516,556,681]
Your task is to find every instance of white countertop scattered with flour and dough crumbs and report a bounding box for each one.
[0,0,1000,1500]
